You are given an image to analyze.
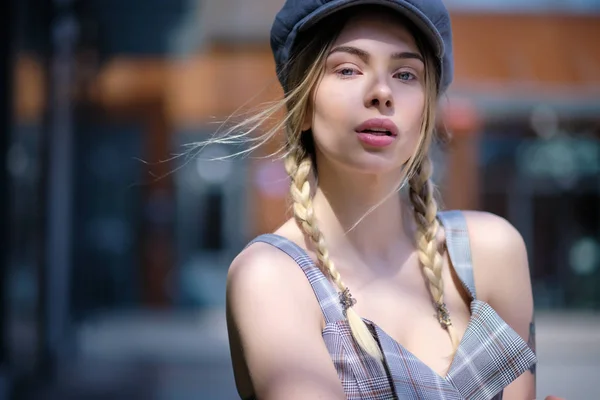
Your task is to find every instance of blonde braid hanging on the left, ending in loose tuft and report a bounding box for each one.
[285,150,383,360]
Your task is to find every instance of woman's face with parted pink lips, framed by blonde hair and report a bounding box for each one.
[303,14,425,174]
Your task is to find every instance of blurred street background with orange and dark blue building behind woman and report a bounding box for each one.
[0,0,600,400]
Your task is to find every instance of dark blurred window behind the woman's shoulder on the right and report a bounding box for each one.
[481,122,600,309]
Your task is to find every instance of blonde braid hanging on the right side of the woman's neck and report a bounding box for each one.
[409,157,459,350]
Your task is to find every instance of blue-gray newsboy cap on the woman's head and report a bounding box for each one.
[271,0,454,94]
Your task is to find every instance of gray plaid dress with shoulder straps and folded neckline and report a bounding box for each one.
[246,211,536,400]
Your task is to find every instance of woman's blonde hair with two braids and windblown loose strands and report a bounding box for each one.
[192,13,458,359]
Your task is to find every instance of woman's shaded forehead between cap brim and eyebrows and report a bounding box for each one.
[334,13,418,51]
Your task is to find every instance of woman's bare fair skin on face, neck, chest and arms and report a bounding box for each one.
[227,12,535,400]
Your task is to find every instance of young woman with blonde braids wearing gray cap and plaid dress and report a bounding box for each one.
[215,0,548,400]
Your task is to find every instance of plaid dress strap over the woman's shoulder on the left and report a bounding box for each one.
[248,233,344,323]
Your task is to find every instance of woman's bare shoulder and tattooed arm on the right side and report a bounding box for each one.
[465,212,536,400]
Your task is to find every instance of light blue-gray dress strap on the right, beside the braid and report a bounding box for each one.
[438,210,477,300]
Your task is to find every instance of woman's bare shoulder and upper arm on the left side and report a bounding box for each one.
[227,243,346,400]
